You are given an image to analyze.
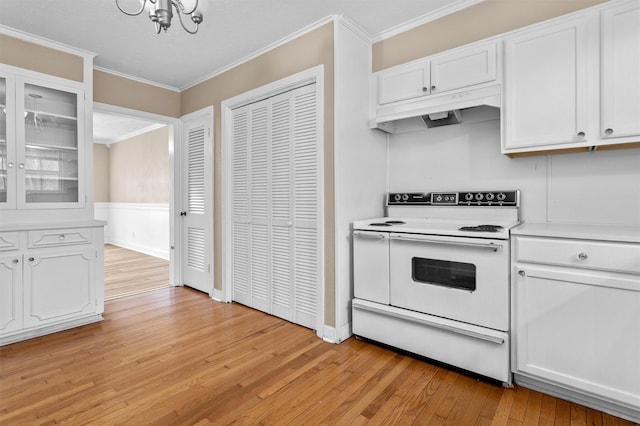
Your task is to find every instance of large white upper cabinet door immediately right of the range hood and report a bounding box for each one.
[503,19,589,152]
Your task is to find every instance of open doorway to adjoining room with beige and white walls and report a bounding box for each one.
[93,104,179,300]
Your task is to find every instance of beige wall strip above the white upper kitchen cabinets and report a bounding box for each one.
[372,0,605,72]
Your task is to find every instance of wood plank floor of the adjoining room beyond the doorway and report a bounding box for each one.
[104,244,169,300]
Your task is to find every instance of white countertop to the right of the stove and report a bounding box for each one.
[511,222,640,243]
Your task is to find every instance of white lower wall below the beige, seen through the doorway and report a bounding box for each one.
[95,203,170,260]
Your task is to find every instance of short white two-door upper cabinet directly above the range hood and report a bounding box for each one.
[377,42,497,105]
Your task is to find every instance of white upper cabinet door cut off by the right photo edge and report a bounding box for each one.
[601,1,640,138]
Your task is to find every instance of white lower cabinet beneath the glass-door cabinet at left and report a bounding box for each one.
[0,226,104,344]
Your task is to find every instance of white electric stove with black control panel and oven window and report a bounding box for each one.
[352,190,520,384]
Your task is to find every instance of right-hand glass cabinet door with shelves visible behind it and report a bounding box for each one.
[17,82,82,208]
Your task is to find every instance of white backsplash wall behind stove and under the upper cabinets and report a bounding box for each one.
[389,117,640,226]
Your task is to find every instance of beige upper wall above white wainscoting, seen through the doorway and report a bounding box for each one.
[109,126,169,204]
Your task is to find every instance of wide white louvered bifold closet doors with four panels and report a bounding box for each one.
[232,85,320,329]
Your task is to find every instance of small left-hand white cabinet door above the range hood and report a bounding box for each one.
[378,61,431,104]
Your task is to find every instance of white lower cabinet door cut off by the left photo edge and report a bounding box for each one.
[0,253,22,334]
